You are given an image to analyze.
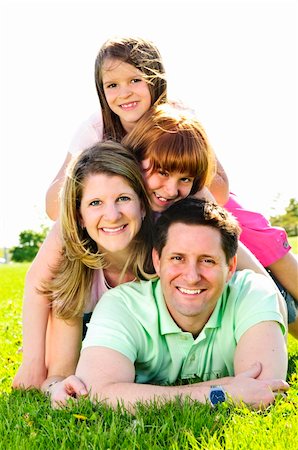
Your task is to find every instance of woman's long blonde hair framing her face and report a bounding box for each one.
[43,141,154,319]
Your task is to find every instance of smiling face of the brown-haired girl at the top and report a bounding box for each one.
[102,59,152,132]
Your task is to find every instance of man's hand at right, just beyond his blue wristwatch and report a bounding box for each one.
[224,362,289,409]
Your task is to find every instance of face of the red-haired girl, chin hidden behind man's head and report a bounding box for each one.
[141,159,194,212]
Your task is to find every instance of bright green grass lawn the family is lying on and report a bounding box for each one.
[0,264,298,450]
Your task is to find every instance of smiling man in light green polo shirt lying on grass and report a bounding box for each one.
[50,198,288,408]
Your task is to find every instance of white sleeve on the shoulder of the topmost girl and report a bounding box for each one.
[68,111,103,155]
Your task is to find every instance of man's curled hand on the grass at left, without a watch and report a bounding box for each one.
[47,375,88,408]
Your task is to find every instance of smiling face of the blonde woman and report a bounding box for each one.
[80,174,144,252]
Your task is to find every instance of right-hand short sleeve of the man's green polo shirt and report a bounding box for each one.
[231,271,286,342]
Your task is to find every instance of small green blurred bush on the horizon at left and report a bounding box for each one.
[10,226,48,262]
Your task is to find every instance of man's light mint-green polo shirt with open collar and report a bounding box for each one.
[82,270,285,385]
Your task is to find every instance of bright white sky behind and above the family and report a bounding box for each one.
[0,0,298,247]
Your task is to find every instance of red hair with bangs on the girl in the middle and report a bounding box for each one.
[122,104,216,194]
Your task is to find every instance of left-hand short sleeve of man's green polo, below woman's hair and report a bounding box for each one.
[82,288,144,363]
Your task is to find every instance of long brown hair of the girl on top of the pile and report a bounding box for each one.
[94,37,167,141]
